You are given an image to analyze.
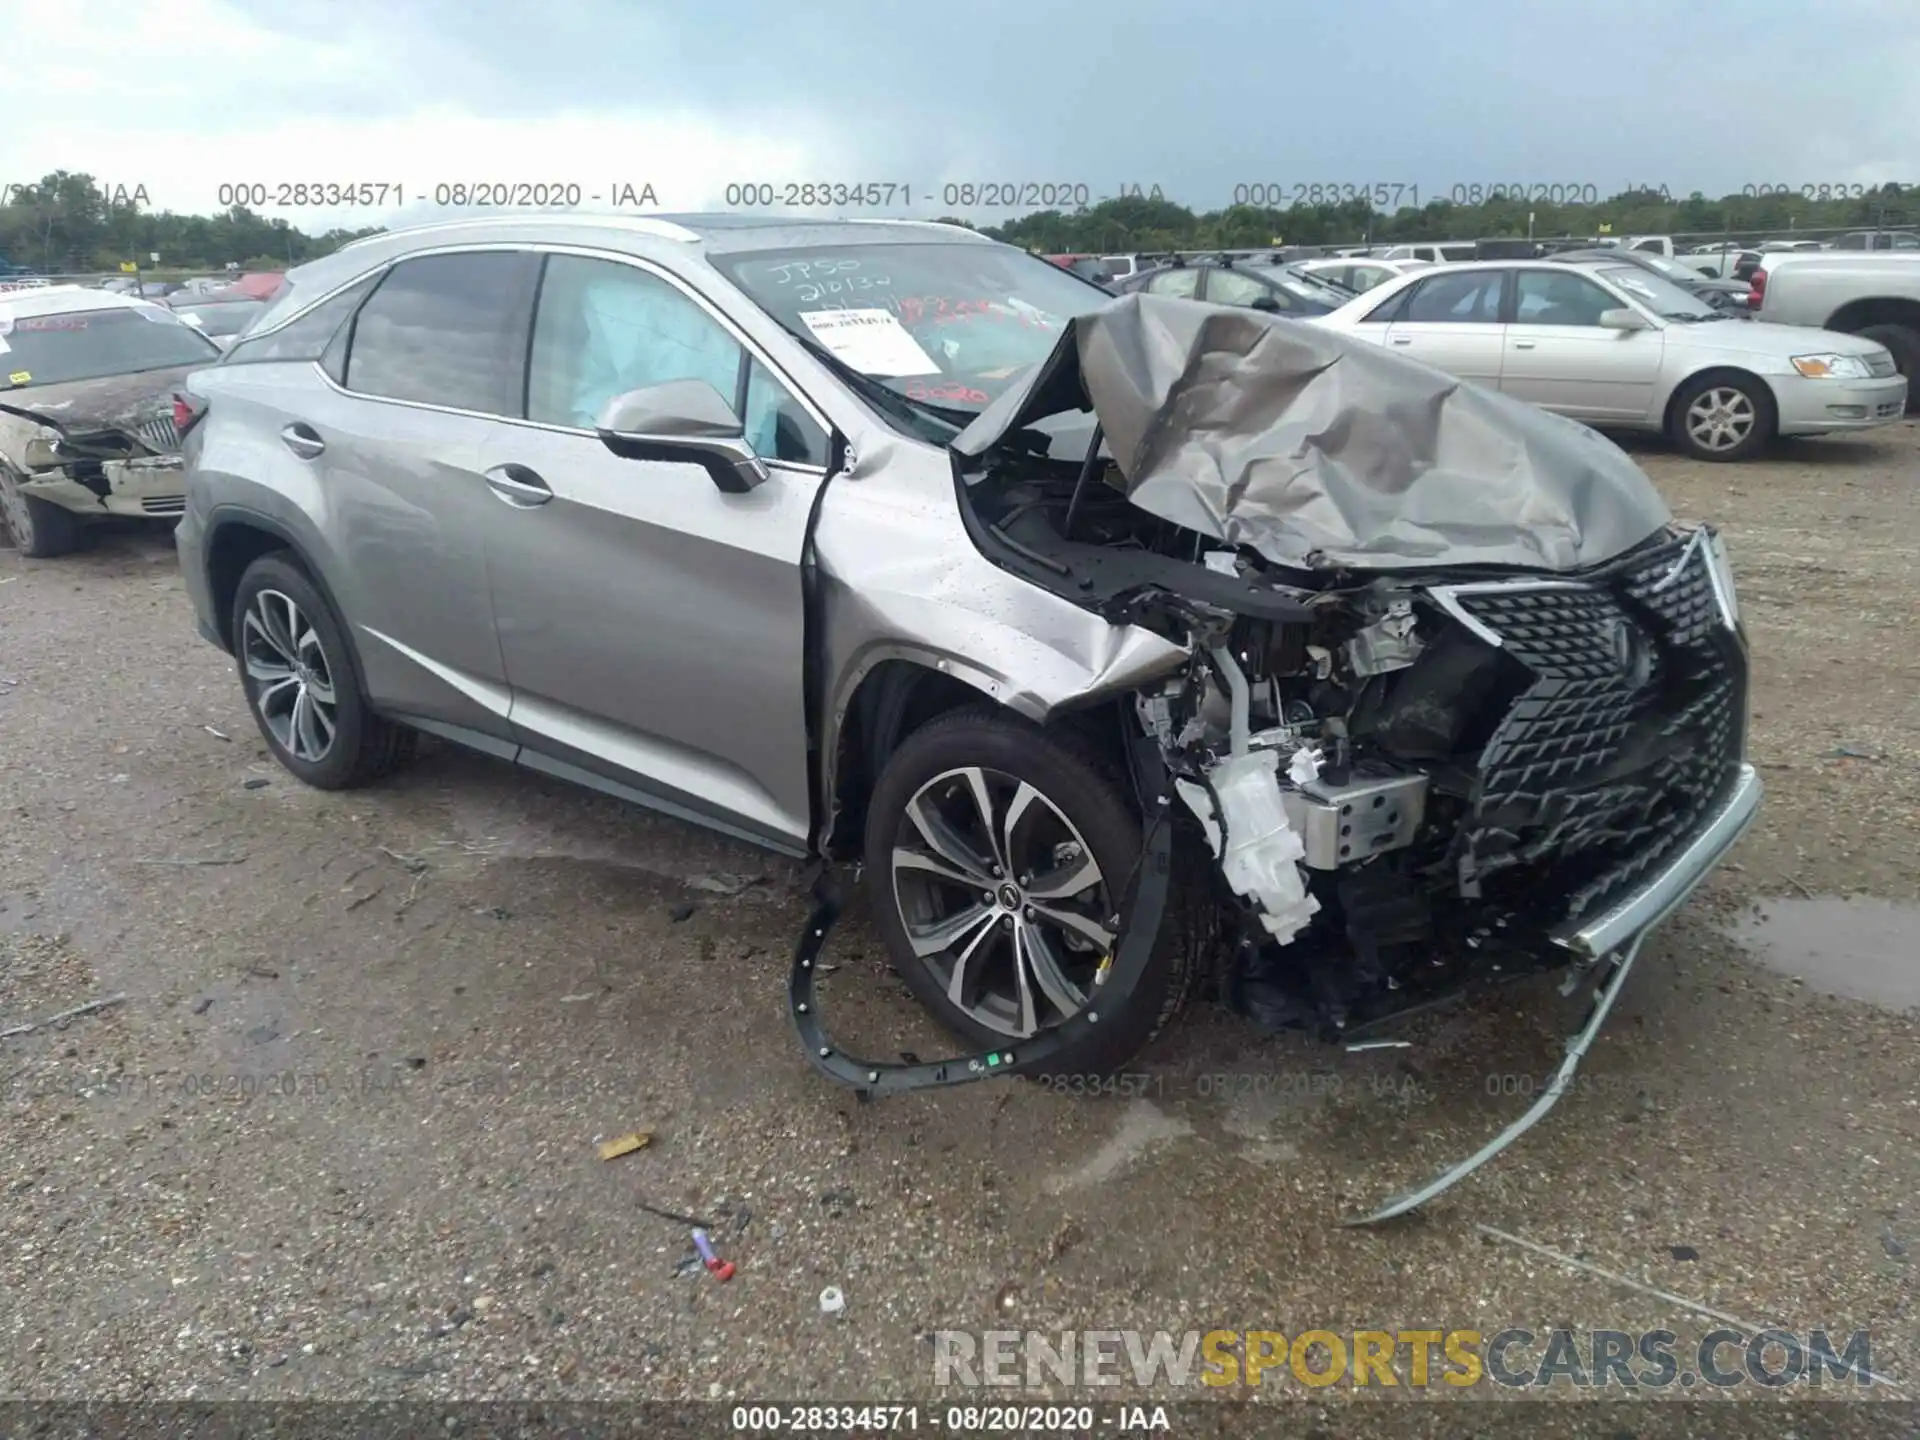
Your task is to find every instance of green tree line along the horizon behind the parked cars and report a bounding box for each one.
[0,171,1920,275]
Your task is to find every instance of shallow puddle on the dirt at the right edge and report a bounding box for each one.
[1728,895,1920,1010]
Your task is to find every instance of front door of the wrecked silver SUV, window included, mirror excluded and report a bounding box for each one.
[478,255,828,851]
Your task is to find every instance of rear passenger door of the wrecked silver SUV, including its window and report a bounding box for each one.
[309,250,540,755]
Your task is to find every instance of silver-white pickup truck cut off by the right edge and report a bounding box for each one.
[1747,250,1920,415]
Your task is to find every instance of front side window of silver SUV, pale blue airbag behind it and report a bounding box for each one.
[526,255,828,465]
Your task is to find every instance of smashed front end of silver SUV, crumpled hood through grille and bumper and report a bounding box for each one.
[954,296,1759,1037]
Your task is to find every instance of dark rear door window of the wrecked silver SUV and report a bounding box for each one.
[342,250,540,419]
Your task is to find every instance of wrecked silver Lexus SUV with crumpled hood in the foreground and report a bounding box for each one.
[179,215,1759,1071]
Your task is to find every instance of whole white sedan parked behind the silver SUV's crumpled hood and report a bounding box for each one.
[1309,261,1907,461]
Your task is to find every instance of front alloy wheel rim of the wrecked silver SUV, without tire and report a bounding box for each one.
[891,766,1117,1037]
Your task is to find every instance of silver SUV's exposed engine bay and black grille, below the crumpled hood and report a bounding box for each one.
[960,445,1745,1037]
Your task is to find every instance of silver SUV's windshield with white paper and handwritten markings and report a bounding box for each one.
[714,244,1112,422]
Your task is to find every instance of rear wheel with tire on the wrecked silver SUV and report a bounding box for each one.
[232,551,415,789]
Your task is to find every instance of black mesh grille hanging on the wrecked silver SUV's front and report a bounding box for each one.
[1457,541,1745,918]
